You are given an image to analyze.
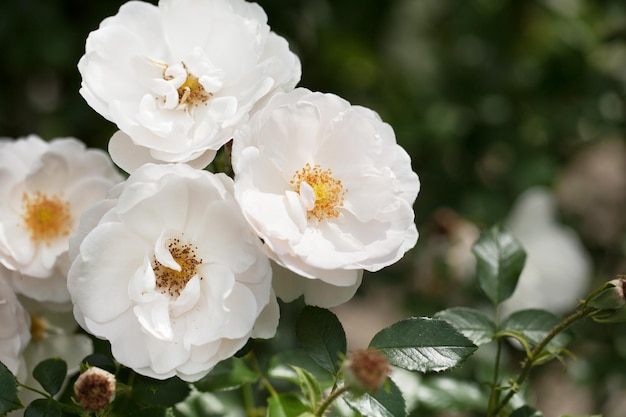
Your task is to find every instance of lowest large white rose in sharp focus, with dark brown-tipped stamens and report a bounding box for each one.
[68,164,278,381]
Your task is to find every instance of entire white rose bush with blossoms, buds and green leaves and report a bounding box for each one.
[0,0,626,417]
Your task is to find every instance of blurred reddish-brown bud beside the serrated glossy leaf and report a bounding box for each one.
[343,349,391,394]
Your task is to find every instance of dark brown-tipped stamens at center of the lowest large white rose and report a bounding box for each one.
[152,239,202,298]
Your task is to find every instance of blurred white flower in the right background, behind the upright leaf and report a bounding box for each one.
[502,187,592,315]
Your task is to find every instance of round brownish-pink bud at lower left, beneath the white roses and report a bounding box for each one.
[74,367,115,411]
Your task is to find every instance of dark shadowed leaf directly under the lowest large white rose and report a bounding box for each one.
[132,375,191,407]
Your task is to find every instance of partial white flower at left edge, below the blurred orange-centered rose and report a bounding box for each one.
[0,276,30,379]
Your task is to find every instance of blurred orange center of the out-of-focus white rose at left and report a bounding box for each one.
[21,192,73,245]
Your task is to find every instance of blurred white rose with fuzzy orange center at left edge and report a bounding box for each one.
[0,135,122,303]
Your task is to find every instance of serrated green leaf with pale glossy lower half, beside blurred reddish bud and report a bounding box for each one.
[370,317,477,372]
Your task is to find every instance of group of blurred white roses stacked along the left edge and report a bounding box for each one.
[0,135,123,402]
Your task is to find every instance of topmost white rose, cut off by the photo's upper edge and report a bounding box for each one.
[78,0,301,172]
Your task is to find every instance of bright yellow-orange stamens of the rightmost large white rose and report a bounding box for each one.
[290,163,348,221]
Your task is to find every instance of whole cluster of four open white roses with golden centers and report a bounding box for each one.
[0,0,420,381]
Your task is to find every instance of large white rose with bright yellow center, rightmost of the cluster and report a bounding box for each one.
[232,88,420,307]
